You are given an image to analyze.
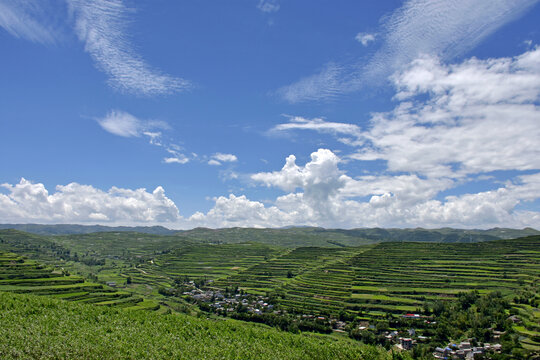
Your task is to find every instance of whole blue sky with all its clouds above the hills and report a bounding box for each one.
[0,0,540,228]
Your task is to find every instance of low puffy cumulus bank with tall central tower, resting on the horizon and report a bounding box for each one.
[187,149,540,228]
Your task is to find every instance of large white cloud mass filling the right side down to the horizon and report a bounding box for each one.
[216,48,540,228]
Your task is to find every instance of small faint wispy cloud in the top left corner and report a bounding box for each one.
[0,0,63,44]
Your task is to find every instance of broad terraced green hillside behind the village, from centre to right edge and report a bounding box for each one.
[210,237,540,349]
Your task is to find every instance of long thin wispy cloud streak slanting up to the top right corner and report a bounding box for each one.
[278,0,539,103]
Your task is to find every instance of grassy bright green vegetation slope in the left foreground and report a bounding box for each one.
[0,292,398,359]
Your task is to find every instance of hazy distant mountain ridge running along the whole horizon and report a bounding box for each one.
[0,224,540,246]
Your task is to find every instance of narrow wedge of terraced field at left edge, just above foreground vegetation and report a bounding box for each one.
[0,252,160,310]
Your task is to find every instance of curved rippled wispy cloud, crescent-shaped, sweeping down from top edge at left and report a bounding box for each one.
[68,0,190,96]
